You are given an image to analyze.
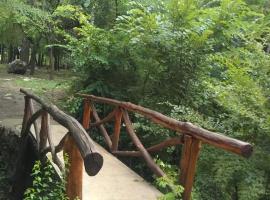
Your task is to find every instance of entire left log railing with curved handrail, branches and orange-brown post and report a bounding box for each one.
[20,89,103,199]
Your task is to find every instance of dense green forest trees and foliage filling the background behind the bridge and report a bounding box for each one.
[0,0,270,200]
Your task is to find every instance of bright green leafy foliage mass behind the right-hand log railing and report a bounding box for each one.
[63,0,270,200]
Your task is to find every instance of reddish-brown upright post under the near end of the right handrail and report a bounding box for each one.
[180,135,201,200]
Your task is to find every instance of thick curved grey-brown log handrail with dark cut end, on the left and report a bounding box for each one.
[20,89,103,176]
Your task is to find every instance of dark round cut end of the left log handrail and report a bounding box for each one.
[84,153,103,176]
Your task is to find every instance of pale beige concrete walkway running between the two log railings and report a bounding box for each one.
[1,119,162,200]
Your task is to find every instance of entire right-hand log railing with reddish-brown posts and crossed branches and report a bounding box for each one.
[78,94,252,200]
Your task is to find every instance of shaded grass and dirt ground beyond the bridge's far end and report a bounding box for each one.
[0,65,73,122]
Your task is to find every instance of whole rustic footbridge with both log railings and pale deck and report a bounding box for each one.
[2,89,252,200]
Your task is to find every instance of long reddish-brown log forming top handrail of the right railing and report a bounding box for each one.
[78,94,252,158]
